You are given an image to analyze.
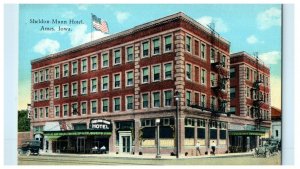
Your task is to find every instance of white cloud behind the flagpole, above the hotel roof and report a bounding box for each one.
[69,24,109,46]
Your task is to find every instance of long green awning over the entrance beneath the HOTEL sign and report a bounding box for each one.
[44,130,112,138]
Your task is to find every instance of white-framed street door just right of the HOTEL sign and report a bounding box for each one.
[119,131,132,153]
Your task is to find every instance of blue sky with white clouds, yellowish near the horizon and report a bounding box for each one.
[18,4,281,109]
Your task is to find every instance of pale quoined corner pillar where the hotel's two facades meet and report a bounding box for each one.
[174,31,185,155]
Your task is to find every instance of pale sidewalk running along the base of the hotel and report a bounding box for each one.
[40,152,252,160]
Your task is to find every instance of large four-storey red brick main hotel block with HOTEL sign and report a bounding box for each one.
[31,13,267,155]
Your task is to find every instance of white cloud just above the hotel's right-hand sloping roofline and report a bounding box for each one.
[197,16,228,32]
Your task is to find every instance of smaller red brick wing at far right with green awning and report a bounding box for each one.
[229,52,271,151]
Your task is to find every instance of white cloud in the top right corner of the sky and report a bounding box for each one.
[256,7,281,30]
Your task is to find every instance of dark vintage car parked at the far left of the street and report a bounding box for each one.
[19,140,41,156]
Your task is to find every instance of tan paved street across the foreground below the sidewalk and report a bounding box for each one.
[18,155,281,165]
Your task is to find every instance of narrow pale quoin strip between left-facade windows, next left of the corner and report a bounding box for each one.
[134,43,140,110]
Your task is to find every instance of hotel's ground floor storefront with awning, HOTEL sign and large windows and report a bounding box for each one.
[34,111,272,156]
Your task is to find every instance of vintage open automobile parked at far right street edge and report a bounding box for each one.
[253,139,280,158]
